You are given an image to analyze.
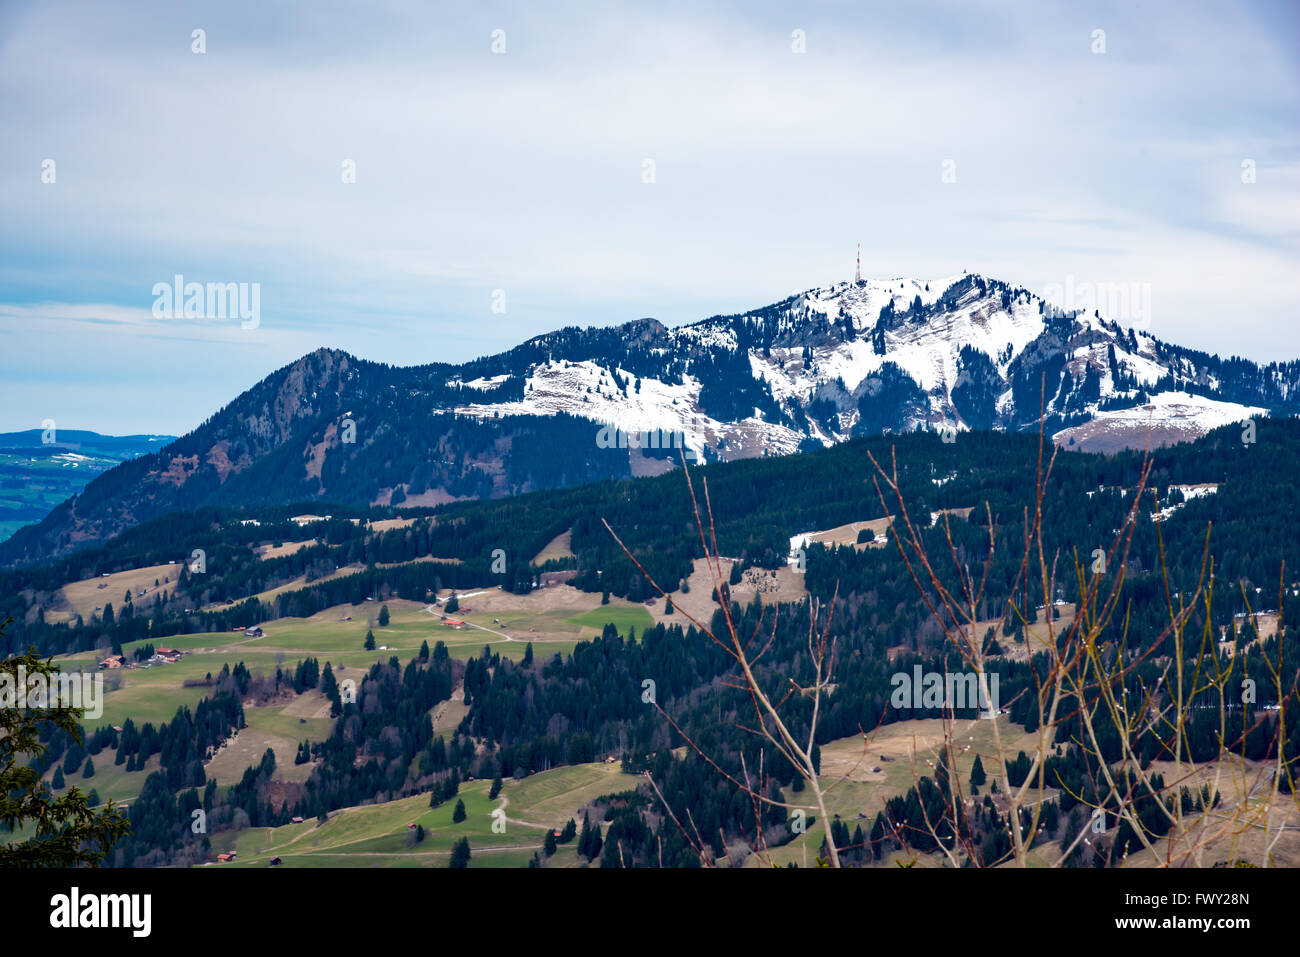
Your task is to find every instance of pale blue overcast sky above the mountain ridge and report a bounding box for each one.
[0,0,1300,433]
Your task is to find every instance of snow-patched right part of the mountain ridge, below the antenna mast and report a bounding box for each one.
[449,274,1297,458]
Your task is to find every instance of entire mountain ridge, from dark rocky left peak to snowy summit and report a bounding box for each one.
[0,274,1300,564]
